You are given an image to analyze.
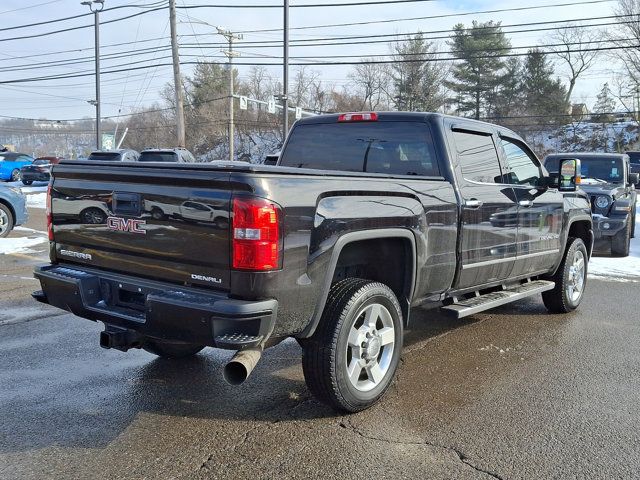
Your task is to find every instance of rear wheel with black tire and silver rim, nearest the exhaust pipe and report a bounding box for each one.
[301,278,403,412]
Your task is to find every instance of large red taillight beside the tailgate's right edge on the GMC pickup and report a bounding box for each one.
[231,197,282,271]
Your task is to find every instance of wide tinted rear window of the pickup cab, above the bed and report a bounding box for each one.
[280,122,440,176]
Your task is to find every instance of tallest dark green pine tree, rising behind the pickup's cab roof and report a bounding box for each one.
[447,21,511,119]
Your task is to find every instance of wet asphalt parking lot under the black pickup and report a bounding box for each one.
[0,193,640,479]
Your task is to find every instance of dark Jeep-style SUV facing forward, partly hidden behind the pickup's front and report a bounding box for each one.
[544,152,639,257]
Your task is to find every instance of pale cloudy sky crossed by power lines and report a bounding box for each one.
[0,0,616,120]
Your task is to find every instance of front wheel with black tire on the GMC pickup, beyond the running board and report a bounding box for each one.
[542,237,589,313]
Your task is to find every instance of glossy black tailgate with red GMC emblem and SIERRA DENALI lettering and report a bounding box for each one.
[51,162,231,290]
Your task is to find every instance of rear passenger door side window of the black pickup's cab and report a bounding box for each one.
[453,130,503,183]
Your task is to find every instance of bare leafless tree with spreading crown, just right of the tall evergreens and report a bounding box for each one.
[551,23,598,104]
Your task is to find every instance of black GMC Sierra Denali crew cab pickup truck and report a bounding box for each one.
[34,113,593,412]
